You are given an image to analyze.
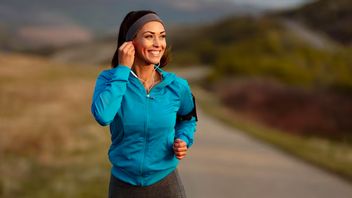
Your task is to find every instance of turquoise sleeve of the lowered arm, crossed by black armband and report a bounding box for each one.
[175,80,196,148]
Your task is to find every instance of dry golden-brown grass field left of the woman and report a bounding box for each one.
[0,54,110,198]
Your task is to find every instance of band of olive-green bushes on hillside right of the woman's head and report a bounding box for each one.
[173,17,352,90]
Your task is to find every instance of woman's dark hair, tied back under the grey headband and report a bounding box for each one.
[111,10,170,68]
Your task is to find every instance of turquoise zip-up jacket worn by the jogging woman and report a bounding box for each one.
[91,65,196,186]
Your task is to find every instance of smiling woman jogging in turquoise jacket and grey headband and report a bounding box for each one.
[91,10,197,197]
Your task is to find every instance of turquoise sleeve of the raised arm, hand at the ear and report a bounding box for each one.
[91,65,131,126]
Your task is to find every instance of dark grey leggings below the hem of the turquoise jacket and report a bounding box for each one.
[109,170,186,198]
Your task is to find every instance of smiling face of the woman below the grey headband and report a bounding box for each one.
[133,21,166,65]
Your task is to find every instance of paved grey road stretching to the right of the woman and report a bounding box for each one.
[179,106,352,198]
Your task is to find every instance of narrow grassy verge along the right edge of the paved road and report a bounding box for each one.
[193,86,352,182]
